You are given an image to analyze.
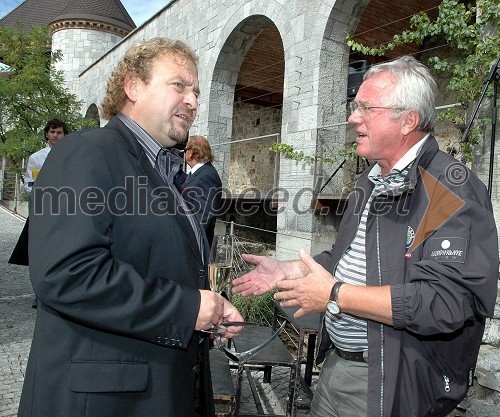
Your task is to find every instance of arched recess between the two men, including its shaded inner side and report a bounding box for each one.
[208,15,285,242]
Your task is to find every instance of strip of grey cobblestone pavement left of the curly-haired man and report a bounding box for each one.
[0,208,36,417]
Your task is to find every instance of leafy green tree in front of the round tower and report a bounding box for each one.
[0,26,95,173]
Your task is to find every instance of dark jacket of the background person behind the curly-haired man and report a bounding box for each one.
[181,162,222,245]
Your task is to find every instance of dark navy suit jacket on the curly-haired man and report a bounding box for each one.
[19,118,213,417]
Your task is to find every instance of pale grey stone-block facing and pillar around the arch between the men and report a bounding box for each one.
[203,0,376,251]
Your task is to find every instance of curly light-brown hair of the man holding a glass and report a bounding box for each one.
[101,38,198,119]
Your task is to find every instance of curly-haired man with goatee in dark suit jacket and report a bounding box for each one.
[18,38,242,417]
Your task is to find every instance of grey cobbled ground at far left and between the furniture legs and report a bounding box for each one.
[0,207,314,417]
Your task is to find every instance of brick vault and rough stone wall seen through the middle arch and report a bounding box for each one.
[229,25,285,198]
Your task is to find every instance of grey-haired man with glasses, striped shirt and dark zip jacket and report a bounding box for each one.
[233,56,498,417]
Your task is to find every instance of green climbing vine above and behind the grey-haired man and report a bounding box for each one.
[347,0,500,162]
